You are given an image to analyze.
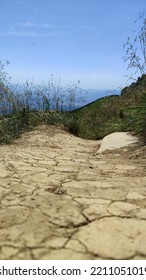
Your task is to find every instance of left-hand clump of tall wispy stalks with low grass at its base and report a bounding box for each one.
[0,62,84,143]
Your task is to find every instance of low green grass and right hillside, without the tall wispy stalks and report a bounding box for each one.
[0,75,146,143]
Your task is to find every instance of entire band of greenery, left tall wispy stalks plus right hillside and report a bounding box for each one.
[0,56,146,143]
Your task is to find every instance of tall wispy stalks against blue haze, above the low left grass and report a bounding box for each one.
[0,74,83,116]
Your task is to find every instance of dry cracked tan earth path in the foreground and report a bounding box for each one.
[0,126,146,260]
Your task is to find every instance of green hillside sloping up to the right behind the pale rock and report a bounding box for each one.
[72,75,146,139]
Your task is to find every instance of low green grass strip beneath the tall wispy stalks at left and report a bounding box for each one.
[0,108,77,144]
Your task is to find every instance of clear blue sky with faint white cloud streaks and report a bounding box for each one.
[0,0,145,89]
